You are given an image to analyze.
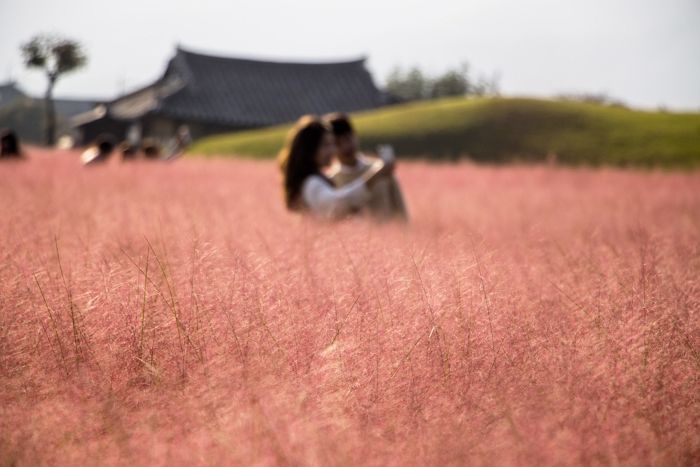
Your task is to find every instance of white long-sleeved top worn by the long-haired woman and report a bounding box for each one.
[301,175,378,219]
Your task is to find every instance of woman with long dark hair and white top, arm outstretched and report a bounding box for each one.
[279,115,393,219]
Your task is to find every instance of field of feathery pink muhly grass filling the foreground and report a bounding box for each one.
[0,150,700,466]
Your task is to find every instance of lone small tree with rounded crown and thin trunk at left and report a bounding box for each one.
[21,34,87,145]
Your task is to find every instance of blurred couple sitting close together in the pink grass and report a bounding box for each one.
[279,113,408,222]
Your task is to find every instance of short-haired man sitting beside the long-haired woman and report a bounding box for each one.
[325,113,408,221]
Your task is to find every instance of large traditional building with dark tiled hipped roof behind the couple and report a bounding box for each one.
[74,47,384,143]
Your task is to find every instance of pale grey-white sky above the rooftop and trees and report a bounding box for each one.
[0,0,700,110]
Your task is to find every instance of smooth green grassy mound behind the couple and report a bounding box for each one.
[190,98,700,167]
